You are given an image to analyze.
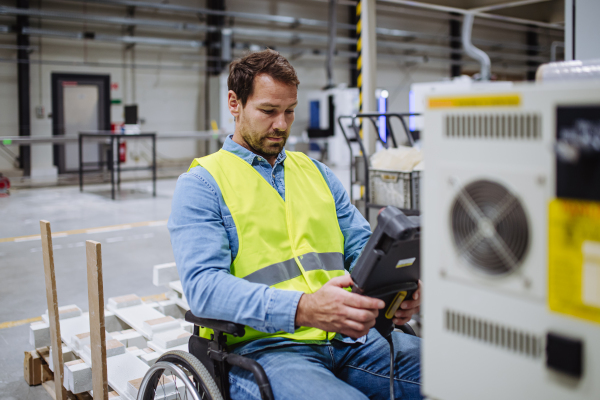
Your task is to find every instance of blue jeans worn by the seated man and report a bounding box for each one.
[229,329,423,400]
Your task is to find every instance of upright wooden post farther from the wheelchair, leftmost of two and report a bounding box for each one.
[40,220,67,400]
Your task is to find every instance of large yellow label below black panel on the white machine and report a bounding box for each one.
[548,199,600,323]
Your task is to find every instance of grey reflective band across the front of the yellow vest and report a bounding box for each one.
[244,253,344,286]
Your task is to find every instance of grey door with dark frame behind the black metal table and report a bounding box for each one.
[52,73,110,173]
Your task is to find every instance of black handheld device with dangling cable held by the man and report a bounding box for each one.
[350,206,421,399]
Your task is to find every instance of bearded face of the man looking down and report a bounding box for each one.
[229,74,298,157]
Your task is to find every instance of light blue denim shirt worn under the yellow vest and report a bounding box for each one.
[168,135,371,339]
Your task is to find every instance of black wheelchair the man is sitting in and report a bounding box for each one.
[137,311,416,400]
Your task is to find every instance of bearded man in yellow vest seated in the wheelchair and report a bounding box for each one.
[168,50,421,400]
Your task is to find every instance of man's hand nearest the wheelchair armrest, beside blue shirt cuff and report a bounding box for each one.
[296,275,385,339]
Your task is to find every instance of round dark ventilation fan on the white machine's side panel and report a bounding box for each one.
[451,180,529,276]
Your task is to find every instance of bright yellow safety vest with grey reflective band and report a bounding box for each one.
[190,150,345,345]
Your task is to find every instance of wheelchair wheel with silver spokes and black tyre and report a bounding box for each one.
[137,350,223,400]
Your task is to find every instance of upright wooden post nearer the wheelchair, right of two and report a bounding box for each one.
[85,240,108,400]
